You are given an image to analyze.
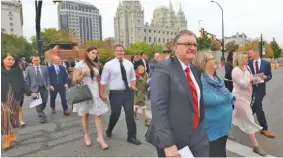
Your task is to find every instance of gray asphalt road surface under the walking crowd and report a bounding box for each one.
[2,68,283,157]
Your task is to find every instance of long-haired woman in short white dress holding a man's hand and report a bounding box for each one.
[73,47,109,150]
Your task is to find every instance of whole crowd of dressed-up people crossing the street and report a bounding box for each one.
[1,30,275,157]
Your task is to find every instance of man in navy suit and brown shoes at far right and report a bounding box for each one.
[249,47,275,138]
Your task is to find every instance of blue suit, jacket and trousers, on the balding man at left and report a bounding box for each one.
[48,65,68,111]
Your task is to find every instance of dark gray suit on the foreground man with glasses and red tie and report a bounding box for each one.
[146,57,209,157]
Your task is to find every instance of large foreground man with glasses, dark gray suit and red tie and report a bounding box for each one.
[146,30,209,157]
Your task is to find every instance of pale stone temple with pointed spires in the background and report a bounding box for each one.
[114,0,187,47]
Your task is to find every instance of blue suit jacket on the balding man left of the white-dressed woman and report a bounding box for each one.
[48,65,68,89]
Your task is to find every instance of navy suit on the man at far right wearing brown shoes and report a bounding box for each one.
[249,59,272,130]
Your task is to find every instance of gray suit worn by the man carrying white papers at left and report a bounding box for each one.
[25,65,50,122]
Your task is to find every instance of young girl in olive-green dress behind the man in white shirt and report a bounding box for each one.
[134,65,150,127]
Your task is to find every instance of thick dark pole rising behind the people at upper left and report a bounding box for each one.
[34,0,43,62]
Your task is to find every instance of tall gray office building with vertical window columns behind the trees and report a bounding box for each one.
[58,1,102,42]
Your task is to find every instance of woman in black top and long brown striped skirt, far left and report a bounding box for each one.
[1,55,36,149]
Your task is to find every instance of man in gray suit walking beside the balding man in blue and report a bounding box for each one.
[25,56,50,123]
